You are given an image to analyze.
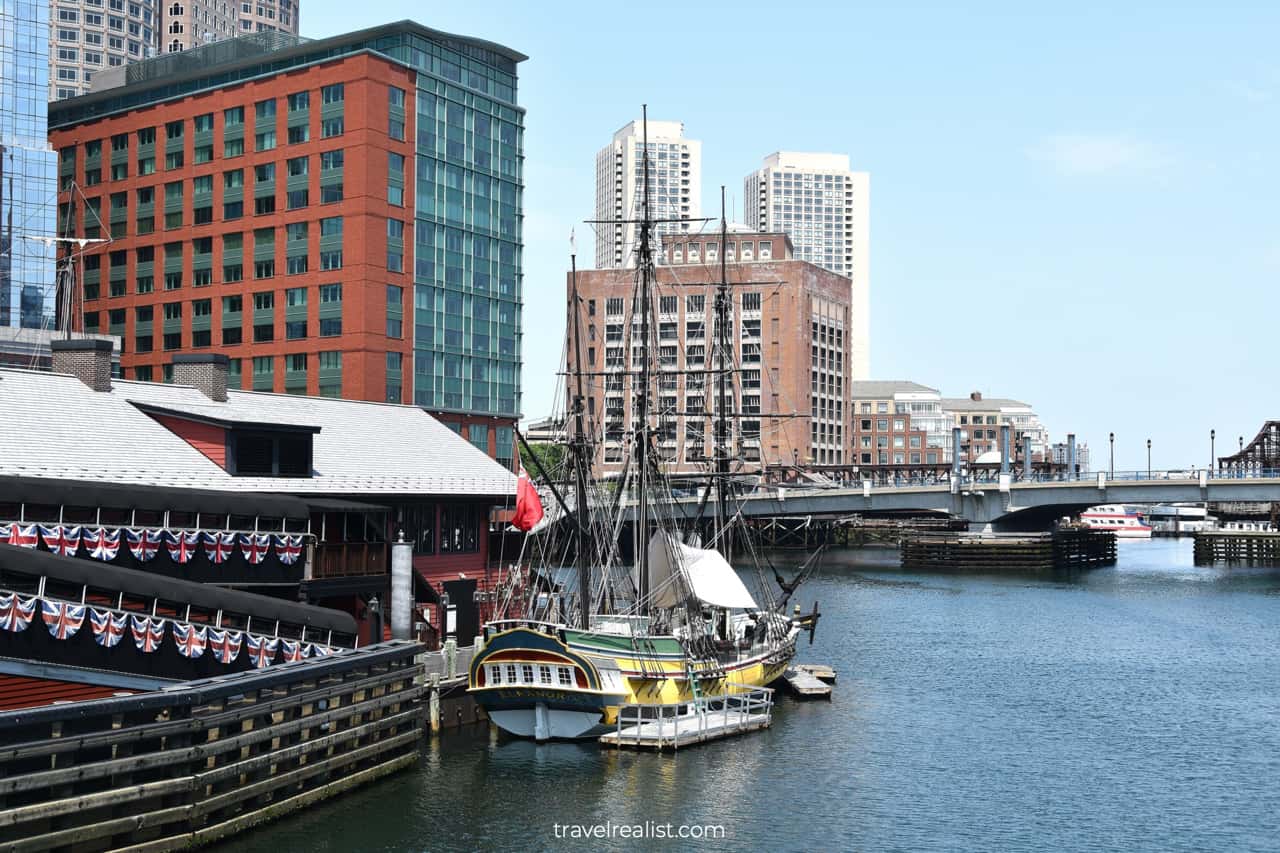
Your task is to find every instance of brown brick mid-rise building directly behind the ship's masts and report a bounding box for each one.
[568,227,851,476]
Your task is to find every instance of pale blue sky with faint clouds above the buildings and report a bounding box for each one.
[301,0,1280,470]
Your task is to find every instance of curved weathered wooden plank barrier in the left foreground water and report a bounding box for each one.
[0,640,426,853]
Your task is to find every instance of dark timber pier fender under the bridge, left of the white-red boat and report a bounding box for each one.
[900,528,1116,573]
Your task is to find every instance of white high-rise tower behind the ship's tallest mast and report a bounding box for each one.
[595,122,703,269]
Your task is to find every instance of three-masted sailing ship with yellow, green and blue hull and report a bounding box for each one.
[468,111,818,740]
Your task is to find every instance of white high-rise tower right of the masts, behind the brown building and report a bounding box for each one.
[742,151,870,379]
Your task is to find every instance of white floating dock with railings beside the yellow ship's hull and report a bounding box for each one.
[600,684,773,751]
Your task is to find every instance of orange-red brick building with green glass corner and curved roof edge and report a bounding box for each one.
[50,22,525,465]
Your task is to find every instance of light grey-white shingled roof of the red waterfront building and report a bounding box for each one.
[0,369,516,496]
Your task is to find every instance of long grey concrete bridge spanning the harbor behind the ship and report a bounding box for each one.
[645,469,1280,530]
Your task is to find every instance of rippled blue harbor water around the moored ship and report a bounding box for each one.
[227,539,1280,853]
